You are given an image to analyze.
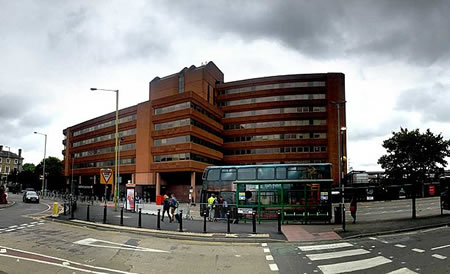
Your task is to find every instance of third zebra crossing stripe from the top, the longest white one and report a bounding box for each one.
[318,256,392,274]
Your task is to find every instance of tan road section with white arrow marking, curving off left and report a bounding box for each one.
[0,195,272,273]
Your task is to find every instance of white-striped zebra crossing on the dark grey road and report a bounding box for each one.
[298,242,416,274]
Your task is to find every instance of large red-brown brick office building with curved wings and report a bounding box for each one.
[63,62,346,201]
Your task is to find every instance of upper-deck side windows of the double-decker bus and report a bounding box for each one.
[206,166,331,181]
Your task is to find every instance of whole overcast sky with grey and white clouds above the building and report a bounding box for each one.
[0,0,450,170]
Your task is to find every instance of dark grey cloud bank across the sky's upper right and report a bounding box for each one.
[161,0,450,66]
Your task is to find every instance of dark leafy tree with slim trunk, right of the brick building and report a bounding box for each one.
[378,128,450,219]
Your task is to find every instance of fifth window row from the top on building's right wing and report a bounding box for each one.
[224,132,327,143]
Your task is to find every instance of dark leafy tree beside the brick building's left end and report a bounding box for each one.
[34,156,64,190]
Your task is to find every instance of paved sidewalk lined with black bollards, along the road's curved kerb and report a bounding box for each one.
[49,199,450,242]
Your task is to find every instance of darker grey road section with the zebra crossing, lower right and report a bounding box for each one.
[267,227,450,274]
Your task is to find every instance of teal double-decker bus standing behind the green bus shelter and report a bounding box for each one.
[201,163,333,222]
